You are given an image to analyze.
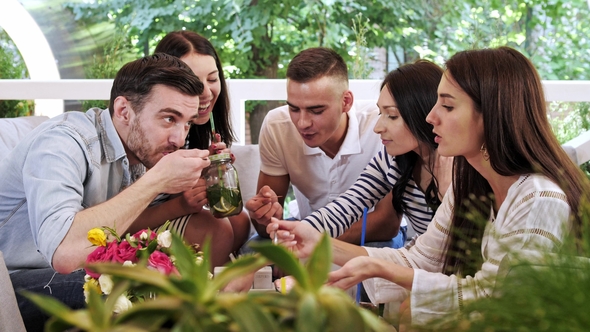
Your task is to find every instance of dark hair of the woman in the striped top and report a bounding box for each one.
[381,60,443,219]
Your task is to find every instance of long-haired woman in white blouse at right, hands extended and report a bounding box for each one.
[267,47,590,330]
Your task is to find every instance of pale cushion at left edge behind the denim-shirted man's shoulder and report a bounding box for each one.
[0,116,49,160]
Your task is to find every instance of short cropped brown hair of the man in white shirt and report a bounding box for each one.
[287,47,348,83]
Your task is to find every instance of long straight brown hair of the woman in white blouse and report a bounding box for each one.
[444,47,589,275]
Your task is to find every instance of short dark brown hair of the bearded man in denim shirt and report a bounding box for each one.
[109,53,203,115]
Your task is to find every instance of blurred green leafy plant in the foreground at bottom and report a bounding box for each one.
[26,236,391,332]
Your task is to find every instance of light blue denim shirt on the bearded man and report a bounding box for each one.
[0,108,130,272]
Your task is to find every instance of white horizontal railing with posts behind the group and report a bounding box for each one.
[0,79,590,163]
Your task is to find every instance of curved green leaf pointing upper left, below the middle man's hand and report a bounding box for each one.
[250,241,311,290]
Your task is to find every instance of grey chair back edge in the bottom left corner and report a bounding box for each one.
[0,251,26,332]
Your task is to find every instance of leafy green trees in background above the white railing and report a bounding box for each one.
[61,0,590,143]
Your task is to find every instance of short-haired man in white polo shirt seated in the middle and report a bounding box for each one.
[246,47,399,244]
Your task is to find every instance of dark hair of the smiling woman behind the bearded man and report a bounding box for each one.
[155,30,236,149]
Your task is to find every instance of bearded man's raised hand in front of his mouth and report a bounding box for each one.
[149,149,211,194]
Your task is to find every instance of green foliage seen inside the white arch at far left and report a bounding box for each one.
[0,29,34,118]
